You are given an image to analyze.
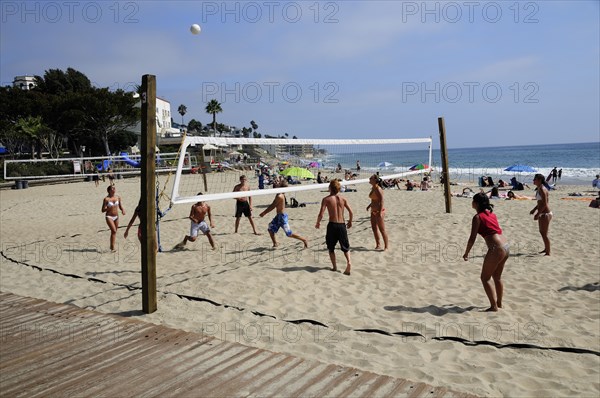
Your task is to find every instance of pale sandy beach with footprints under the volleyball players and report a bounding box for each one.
[0,177,600,397]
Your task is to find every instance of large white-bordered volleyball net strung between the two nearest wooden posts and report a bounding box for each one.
[171,136,432,204]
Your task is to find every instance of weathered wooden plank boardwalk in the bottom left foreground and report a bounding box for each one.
[0,293,478,398]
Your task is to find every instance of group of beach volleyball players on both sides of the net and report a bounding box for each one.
[102,174,552,311]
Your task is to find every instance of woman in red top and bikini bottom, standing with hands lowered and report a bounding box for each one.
[463,193,510,311]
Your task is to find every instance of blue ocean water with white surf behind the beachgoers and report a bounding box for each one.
[322,141,600,187]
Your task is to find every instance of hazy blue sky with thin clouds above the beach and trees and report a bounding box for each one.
[0,0,600,148]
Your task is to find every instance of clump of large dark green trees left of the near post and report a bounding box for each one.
[0,68,140,156]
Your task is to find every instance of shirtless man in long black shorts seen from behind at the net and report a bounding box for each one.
[315,180,353,275]
